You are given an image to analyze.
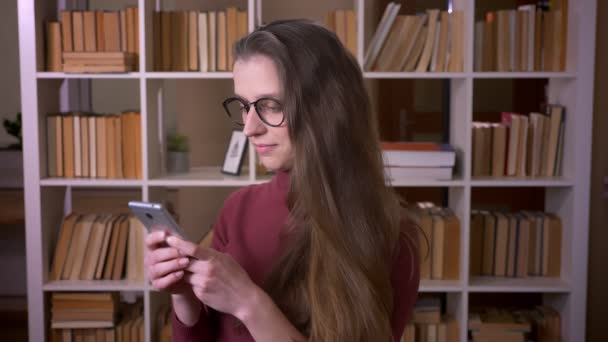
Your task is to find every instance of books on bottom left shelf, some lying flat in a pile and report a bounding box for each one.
[51,292,145,342]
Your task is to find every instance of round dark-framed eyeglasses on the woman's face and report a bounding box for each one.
[222,97,285,127]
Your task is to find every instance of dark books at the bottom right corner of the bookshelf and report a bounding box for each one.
[468,306,561,342]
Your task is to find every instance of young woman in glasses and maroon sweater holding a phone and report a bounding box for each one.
[146,20,419,342]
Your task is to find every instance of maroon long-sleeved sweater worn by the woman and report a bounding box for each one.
[173,172,419,342]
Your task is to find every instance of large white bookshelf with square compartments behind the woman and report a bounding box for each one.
[18,0,596,341]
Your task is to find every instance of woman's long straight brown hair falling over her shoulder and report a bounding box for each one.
[234,20,415,342]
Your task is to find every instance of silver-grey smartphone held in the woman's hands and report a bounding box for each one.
[129,201,185,238]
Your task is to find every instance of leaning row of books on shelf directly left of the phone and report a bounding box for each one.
[49,213,146,282]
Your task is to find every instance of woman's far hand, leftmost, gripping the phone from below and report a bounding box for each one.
[144,231,191,295]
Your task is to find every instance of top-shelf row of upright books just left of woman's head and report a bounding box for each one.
[153,7,249,71]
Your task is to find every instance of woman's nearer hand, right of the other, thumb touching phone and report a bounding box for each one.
[167,236,259,321]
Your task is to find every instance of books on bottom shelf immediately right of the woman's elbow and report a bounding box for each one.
[401,295,459,342]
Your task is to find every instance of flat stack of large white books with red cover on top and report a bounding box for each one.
[381,142,456,181]
